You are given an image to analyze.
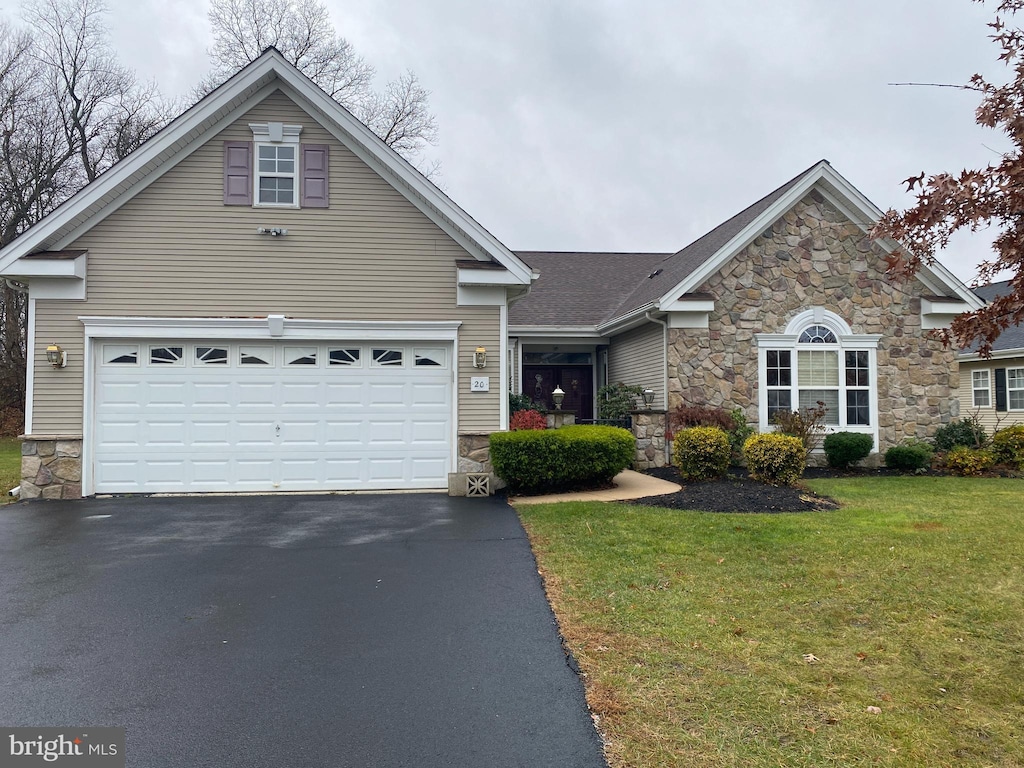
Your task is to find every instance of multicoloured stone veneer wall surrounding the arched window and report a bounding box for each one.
[668,191,958,453]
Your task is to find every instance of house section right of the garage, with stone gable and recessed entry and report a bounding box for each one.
[509,161,982,452]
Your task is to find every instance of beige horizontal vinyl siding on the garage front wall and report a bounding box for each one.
[33,91,500,433]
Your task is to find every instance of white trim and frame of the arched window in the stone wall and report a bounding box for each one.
[754,307,882,451]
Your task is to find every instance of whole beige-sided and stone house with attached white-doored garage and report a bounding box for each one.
[0,49,981,498]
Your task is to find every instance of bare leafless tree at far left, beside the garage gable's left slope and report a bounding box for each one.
[0,0,174,415]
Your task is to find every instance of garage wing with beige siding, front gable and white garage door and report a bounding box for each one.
[0,49,535,498]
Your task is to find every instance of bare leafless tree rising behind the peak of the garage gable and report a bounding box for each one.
[196,0,437,165]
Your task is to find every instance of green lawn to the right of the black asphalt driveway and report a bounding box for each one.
[519,477,1024,767]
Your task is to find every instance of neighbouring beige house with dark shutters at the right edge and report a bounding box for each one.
[959,281,1024,432]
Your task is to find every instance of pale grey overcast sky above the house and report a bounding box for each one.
[99,0,1007,282]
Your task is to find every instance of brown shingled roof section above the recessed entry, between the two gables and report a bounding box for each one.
[509,251,670,328]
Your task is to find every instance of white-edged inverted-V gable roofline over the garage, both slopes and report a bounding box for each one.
[0,48,535,285]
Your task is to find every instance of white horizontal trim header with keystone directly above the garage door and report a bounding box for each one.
[79,315,462,341]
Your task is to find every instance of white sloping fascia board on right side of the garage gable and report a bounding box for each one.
[279,75,532,285]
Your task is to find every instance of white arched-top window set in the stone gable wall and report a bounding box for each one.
[757,307,881,433]
